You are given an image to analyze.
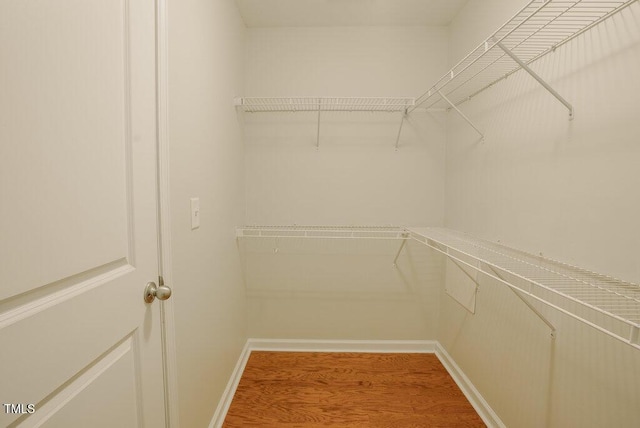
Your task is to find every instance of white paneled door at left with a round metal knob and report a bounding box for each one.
[0,0,165,428]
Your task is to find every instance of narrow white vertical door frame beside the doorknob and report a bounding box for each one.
[156,0,180,428]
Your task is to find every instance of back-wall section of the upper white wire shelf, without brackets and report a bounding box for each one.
[236,97,415,113]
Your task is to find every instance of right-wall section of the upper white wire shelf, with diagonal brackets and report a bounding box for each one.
[409,0,638,135]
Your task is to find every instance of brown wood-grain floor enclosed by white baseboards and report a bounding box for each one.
[223,352,485,428]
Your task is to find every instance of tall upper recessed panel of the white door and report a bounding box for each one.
[0,0,131,299]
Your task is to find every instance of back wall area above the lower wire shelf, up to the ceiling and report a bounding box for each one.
[244,27,448,225]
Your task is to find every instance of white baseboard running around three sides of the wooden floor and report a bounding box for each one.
[209,339,506,428]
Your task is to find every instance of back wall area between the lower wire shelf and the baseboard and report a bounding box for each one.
[242,238,443,340]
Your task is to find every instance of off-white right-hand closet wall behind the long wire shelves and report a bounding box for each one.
[439,0,640,427]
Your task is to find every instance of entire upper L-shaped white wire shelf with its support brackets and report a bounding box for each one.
[235,0,638,144]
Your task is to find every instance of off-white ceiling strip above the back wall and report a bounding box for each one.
[236,0,468,28]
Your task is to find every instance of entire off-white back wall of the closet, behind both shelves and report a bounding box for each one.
[243,27,448,339]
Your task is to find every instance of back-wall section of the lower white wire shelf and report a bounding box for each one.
[236,226,410,240]
